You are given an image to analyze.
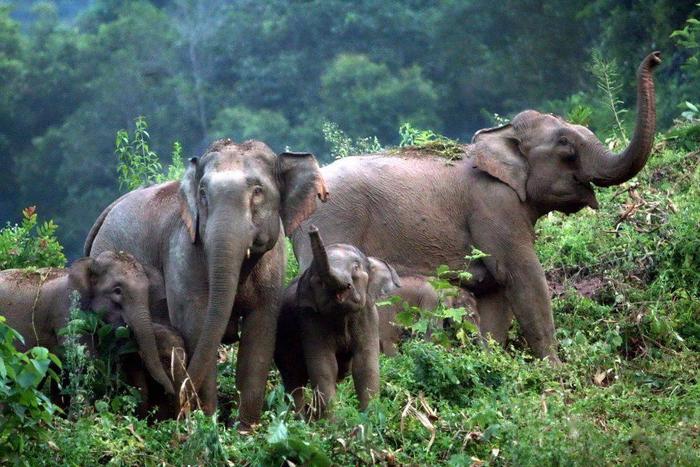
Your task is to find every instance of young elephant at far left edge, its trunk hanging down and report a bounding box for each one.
[0,251,174,394]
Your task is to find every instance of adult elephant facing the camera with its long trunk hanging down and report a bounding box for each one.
[85,139,327,428]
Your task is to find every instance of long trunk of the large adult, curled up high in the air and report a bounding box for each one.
[582,52,661,187]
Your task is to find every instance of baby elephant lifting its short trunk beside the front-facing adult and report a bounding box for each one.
[275,226,400,418]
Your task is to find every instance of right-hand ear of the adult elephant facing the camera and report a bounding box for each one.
[276,152,328,235]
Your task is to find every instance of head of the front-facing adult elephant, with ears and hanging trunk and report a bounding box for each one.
[180,139,328,388]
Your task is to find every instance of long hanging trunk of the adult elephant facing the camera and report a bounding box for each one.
[187,218,253,391]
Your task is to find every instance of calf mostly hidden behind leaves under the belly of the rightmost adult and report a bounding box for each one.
[378,276,479,357]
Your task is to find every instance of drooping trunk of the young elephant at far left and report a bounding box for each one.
[124,302,175,394]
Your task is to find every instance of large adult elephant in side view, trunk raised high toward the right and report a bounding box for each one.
[293,52,661,363]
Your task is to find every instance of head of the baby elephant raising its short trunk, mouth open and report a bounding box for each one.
[297,226,401,313]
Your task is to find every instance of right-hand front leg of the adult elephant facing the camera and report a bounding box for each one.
[236,306,278,428]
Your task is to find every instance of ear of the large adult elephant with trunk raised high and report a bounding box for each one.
[472,124,528,202]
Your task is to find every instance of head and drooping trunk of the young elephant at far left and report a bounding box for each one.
[68,251,174,394]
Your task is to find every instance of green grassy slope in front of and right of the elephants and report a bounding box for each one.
[17,133,700,465]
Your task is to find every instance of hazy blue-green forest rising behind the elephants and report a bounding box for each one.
[0,0,700,257]
